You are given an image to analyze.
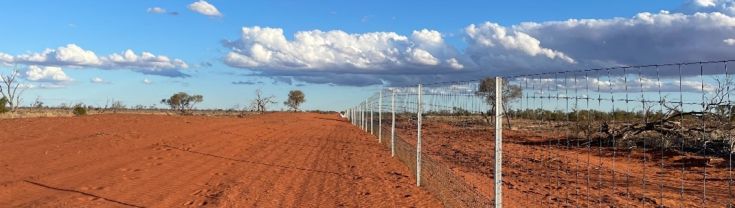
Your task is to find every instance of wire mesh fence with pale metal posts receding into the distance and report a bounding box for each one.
[348,61,735,207]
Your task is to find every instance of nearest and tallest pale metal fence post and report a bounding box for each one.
[493,77,504,208]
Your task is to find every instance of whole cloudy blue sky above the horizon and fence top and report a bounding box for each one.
[0,0,735,110]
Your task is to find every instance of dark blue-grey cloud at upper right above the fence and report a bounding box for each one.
[513,11,735,70]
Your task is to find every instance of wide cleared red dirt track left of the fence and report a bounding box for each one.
[0,113,441,207]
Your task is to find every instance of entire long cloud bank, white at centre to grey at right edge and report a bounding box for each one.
[224,0,735,86]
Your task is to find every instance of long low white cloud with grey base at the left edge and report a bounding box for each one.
[0,44,189,77]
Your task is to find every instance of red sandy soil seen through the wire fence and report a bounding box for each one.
[397,119,735,207]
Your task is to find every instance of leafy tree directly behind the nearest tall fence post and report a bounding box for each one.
[475,77,523,127]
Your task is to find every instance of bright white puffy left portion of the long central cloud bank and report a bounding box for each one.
[225,26,462,73]
